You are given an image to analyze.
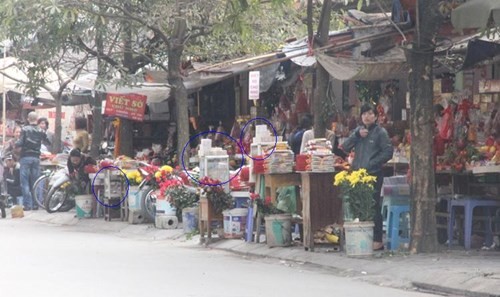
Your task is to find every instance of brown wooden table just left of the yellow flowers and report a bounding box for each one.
[300,172,344,251]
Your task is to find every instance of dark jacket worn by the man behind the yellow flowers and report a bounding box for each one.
[342,124,394,174]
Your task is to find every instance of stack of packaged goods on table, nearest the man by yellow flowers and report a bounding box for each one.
[296,138,337,172]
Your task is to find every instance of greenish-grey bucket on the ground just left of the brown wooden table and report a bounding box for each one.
[264,214,292,247]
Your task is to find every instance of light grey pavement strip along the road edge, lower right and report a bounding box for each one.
[209,241,500,297]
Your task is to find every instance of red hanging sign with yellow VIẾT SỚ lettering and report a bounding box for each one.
[104,93,147,122]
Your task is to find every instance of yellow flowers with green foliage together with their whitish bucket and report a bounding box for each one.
[333,168,377,256]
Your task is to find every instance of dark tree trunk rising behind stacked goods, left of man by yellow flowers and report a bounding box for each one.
[312,0,332,138]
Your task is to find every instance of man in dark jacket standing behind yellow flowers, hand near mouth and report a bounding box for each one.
[342,104,394,250]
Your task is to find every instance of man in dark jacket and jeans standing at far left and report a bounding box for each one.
[16,111,50,210]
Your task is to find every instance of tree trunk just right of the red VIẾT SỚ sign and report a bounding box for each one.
[168,18,189,169]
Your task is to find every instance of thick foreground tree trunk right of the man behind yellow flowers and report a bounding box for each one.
[407,0,439,253]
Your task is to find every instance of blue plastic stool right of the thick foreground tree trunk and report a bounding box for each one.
[448,199,500,249]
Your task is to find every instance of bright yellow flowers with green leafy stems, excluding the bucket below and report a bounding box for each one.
[333,168,377,221]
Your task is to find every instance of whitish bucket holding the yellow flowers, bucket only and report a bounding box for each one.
[344,222,375,256]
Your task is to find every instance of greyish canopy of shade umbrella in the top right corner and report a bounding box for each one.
[451,0,500,30]
